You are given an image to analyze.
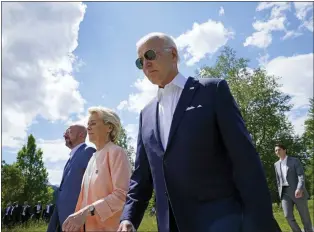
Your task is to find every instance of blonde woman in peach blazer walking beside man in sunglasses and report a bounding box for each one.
[62,107,131,232]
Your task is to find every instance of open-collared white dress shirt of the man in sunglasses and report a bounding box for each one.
[157,73,187,149]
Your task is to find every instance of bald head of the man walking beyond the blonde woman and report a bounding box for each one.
[64,124,87,149]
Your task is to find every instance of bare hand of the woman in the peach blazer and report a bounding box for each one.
[62,206,89,231]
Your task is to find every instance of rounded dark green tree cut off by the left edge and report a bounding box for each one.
[1,161,25,208]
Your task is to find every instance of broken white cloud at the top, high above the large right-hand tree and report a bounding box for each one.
[243,2,292,48]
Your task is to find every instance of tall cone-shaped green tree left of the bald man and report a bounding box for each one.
[16,135,50,203]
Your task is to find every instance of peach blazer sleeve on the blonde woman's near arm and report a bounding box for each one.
[93,148,131,222]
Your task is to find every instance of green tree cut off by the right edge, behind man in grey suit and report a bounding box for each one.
[303,98,314,196]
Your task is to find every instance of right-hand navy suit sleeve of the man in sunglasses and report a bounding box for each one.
[216,80,275,232]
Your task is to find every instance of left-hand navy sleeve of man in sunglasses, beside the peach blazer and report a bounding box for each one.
[121,111,153,229]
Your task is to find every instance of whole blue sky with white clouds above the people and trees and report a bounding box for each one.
[2,2,313,184]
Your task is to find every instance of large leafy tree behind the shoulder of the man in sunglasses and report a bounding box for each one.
[199,47,303,200]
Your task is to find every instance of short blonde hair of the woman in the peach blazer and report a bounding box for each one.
[88,106,121,143]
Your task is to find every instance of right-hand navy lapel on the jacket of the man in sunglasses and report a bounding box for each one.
[166,77,199,150]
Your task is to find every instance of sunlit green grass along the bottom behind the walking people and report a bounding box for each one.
[2,200,314,232]
